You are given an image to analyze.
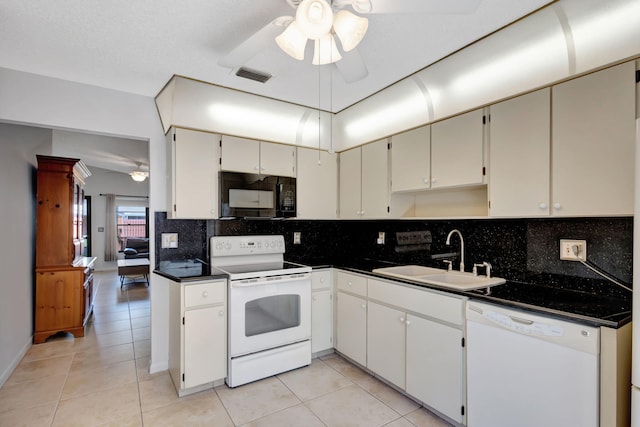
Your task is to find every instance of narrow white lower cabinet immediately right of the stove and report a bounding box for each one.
[311,269,333,353]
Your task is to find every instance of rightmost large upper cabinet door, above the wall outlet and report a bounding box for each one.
[551,61,636,216]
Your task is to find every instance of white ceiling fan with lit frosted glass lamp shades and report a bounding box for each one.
[218,0,482,83]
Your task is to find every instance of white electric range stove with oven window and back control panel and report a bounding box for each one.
[210,236,311,387]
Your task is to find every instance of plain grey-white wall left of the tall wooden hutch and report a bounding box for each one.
[0,123,51,385]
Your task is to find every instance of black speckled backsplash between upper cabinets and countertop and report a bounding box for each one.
[155,212,633,283]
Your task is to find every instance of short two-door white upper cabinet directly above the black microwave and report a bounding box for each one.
[220,135,296,177]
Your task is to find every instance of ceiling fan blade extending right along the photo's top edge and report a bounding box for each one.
[360,0,482,15]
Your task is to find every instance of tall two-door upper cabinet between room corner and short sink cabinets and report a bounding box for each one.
[339,139,389,218]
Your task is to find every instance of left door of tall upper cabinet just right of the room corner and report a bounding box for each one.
[340,147,362,218]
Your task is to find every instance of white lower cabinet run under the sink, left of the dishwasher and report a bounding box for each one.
[336,271,466,424]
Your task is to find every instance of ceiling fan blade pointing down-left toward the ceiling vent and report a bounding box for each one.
[218,16,293,68]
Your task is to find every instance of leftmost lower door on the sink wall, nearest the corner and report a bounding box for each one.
[336,292,367,366]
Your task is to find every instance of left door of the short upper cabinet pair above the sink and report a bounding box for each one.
[391,126,431,192]
